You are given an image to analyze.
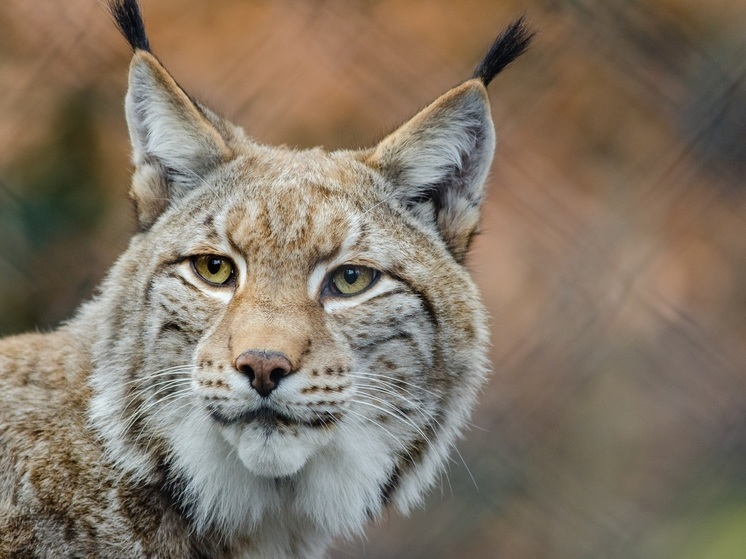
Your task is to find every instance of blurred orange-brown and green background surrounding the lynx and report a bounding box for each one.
[0,0,746,559]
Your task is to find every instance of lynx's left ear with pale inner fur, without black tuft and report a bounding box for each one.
[125,50,230,229]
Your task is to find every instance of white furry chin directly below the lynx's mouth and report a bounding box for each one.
[222,425,326,478]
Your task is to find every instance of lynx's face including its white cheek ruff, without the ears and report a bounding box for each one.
[93,122,487,531]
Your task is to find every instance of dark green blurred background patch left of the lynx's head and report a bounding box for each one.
[0,91,113,334]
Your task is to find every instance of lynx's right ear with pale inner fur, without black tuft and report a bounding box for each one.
[368,79,495,262]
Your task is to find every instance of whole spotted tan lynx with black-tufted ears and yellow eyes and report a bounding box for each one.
[0,0,531,559]
